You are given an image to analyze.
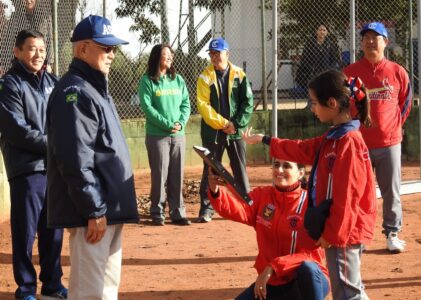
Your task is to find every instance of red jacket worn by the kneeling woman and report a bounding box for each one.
[208,186,329,285]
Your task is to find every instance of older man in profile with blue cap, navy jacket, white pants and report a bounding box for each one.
[47,15,138,300]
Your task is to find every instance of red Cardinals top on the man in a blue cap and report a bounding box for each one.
[344,58,412,149]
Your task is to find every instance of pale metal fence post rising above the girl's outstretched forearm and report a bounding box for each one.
[272,0,278,137]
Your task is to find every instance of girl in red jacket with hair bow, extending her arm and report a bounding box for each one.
[243,70,376,300]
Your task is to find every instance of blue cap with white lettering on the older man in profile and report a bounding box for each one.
[70,15,129,46]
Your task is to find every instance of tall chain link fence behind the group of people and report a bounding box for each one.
[0,0,418,119]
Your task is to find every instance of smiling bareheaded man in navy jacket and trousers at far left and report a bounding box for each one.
[0,29,67,300]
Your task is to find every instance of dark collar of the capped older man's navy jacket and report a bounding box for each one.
[69,58,108,97]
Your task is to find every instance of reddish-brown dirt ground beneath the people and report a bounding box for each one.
[0,164,421,300]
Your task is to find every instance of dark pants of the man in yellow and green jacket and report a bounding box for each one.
[199,132,250,216]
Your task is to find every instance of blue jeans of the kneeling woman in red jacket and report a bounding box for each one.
[235,261,329,300]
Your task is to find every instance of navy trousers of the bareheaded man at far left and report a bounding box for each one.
[9,172,63,298]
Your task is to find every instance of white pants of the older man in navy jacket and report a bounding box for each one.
[68,225,123,300]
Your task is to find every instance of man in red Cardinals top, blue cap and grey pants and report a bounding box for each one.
[344,22,412,253]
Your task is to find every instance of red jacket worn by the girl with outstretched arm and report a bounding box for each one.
[270,121,376,247]
